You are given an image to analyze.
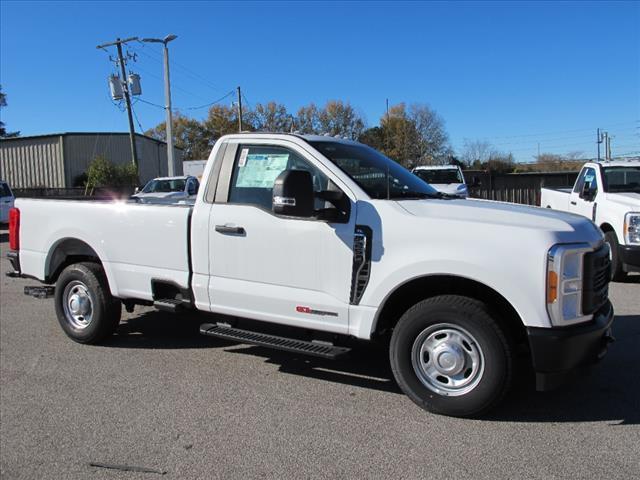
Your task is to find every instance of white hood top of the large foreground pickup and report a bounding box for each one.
[398,199,602,243]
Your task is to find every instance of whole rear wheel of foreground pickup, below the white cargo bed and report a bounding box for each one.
[55,262,122,344]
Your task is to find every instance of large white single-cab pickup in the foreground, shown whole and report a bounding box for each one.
[8,134,613,416]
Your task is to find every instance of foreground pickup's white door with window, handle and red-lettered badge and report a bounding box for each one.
[209,140,355,333]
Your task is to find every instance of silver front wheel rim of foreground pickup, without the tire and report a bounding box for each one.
[411,323,484,396]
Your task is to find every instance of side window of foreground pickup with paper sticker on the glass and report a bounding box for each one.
[229,145,329,211]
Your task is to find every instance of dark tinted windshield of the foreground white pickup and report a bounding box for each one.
[310,141,440,199]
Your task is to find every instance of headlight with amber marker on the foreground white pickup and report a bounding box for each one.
[547,243,593,327]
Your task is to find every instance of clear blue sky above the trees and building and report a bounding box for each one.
[0,0,640,162]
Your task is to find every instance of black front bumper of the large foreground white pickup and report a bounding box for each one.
[527,302,613,391]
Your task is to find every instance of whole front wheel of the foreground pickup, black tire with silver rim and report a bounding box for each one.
[389,295,514,417]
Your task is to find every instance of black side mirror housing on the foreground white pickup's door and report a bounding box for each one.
[272,170,314,217]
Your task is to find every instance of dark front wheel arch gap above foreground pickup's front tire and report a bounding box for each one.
[372,275,526,343]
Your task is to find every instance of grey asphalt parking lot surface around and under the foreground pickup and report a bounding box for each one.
[0,231,640,479]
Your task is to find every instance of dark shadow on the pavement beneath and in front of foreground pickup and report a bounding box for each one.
[105,311,640,426]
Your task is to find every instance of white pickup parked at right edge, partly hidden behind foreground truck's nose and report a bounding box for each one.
[540,160,640,280]
